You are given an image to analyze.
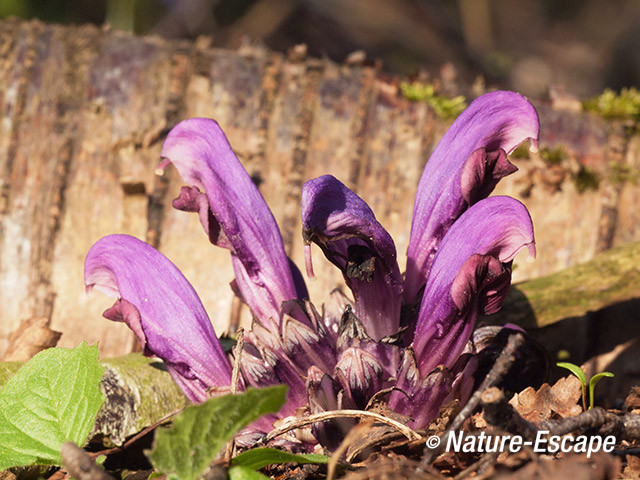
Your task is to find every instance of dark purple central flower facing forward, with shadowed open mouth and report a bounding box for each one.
[302,175,402,340]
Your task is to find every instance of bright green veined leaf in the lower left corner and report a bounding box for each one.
[0,342,104,470]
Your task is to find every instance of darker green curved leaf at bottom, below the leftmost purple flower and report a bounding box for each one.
[149,385,287,480]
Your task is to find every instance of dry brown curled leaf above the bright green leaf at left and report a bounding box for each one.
[2,317,62,362]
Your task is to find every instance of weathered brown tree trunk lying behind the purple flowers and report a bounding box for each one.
[0,20,640,356]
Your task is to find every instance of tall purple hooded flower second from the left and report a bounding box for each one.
[161,118,307,321]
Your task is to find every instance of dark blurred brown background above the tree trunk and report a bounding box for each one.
[0,0,640,98]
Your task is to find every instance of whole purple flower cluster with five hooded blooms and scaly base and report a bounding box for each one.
[85,92,538,447]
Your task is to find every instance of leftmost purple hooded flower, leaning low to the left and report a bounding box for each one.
[84,235,231,402]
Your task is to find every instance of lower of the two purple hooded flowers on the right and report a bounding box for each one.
[413,196,535,376]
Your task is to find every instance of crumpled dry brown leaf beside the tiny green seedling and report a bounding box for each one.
[509,375,582,423]
